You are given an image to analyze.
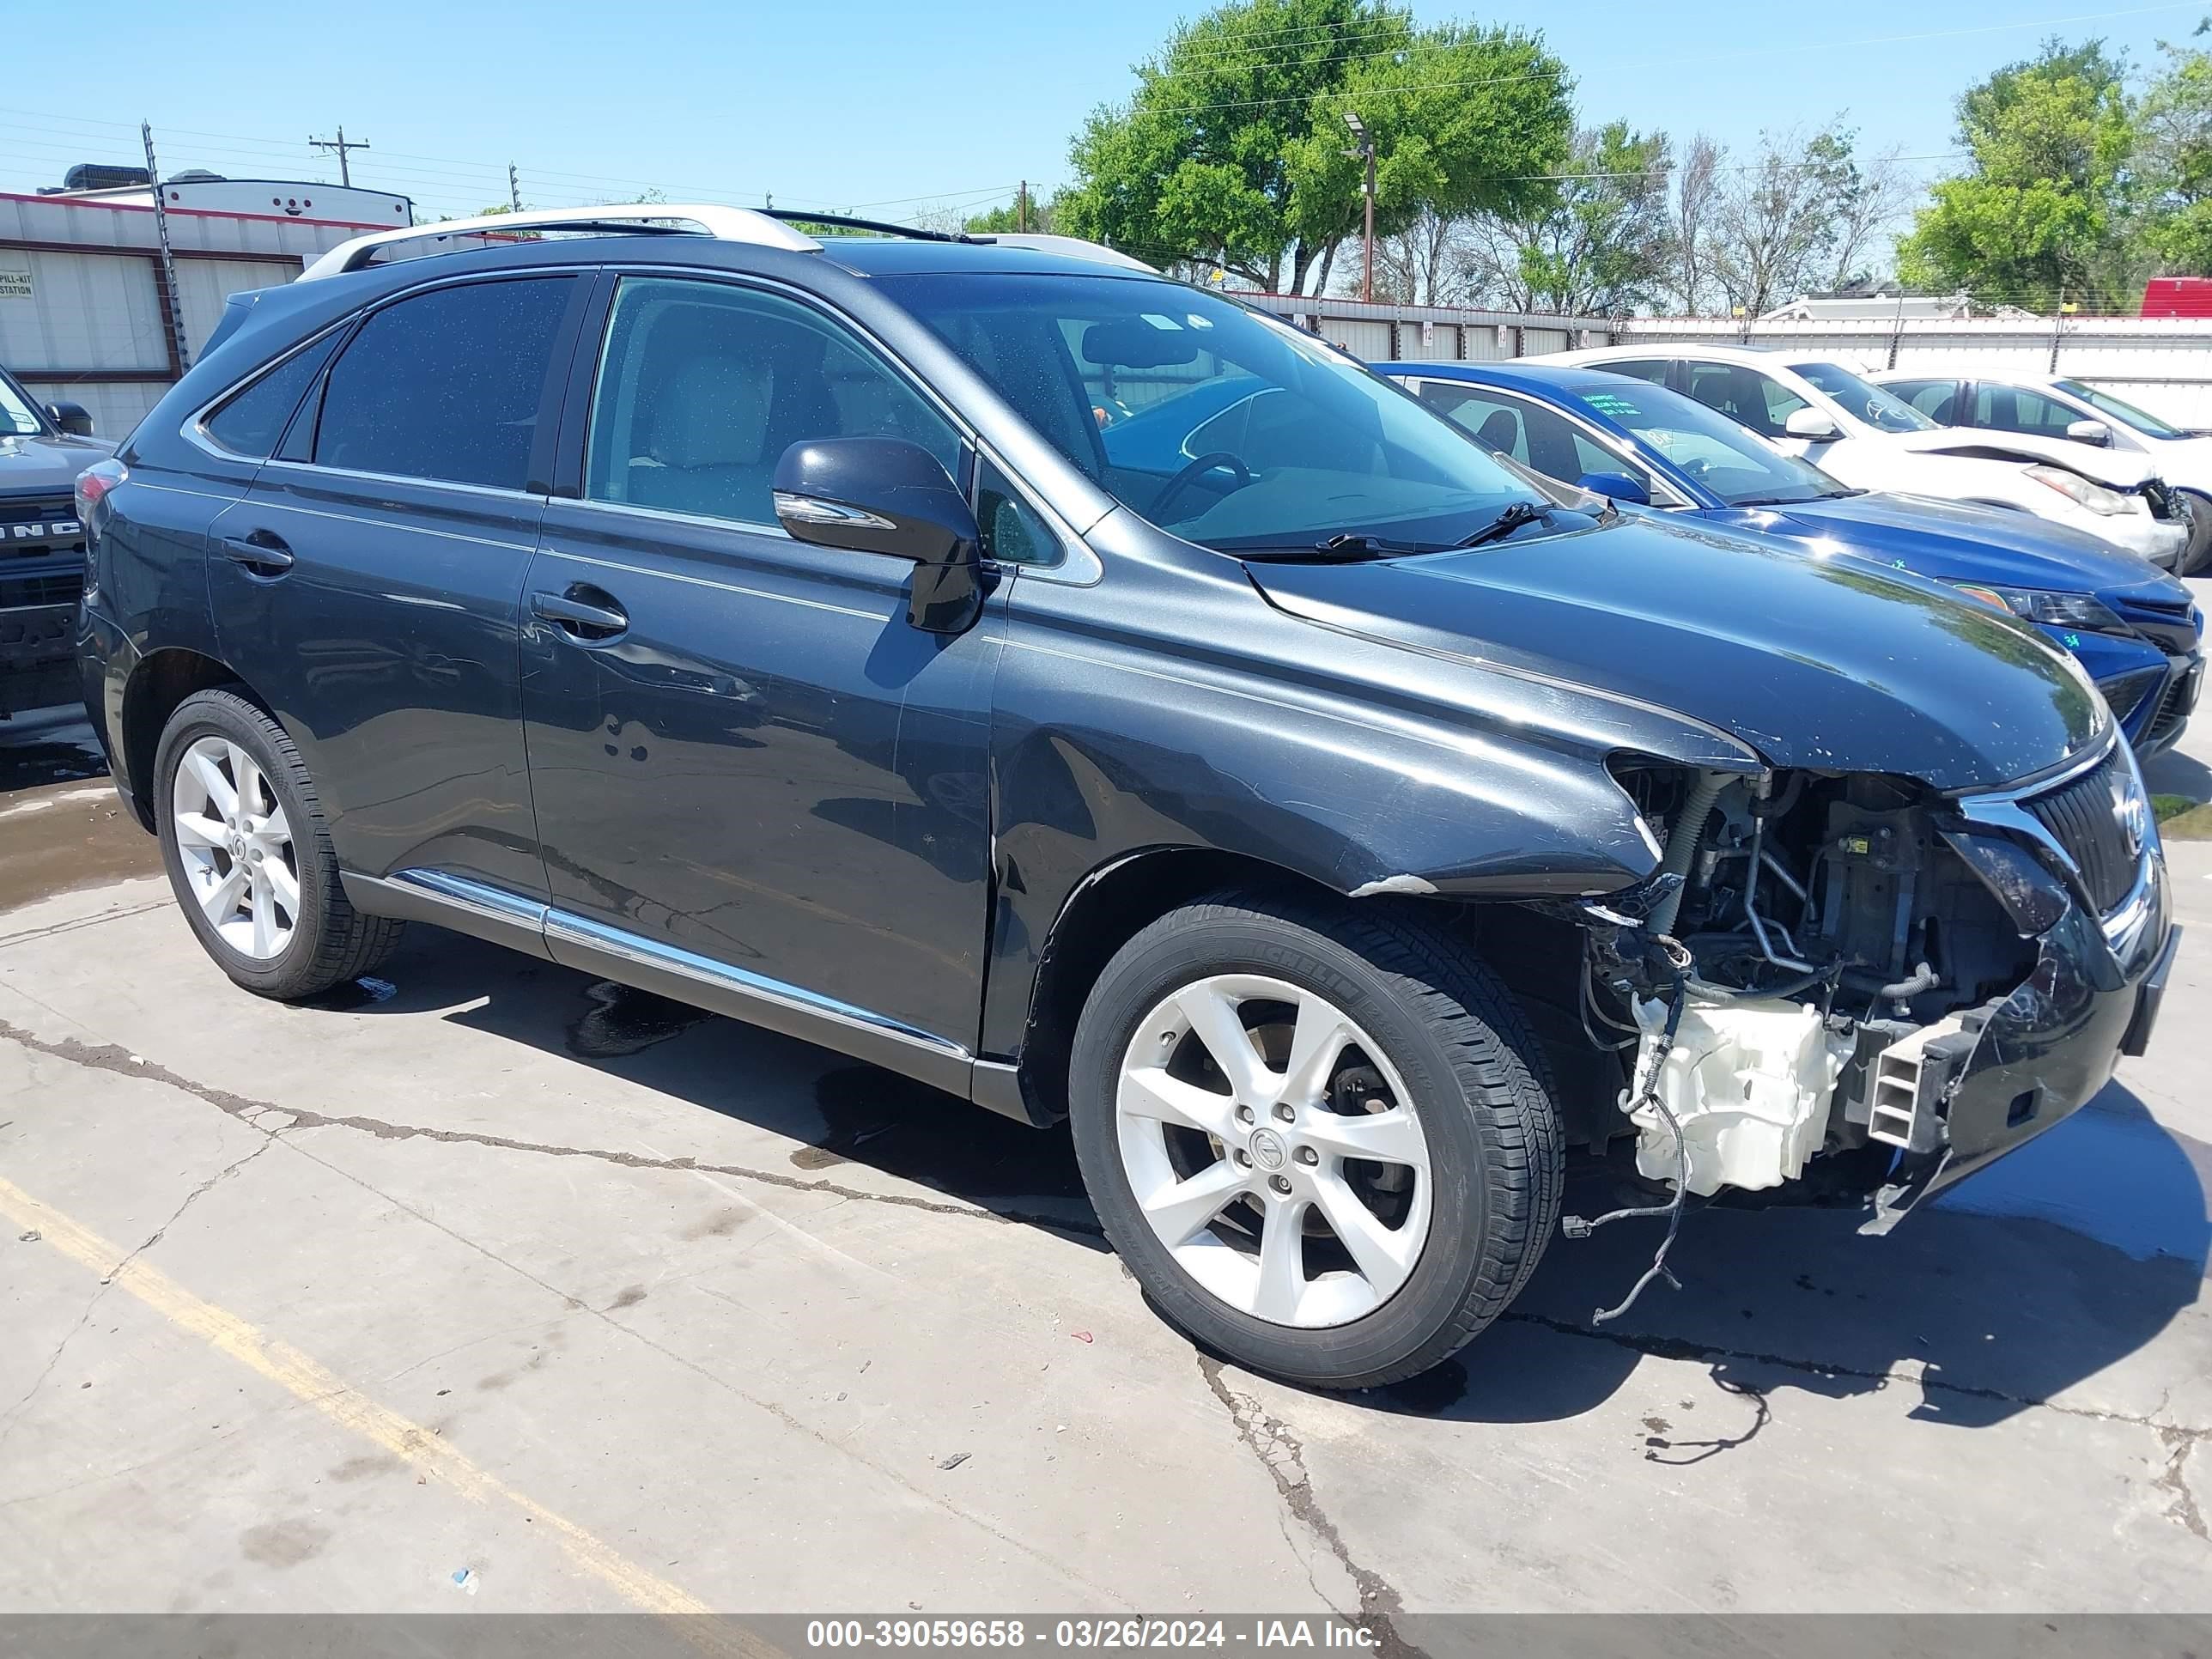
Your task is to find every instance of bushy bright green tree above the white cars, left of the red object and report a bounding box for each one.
[1898,40,2135,310]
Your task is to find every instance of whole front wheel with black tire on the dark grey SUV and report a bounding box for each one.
[1068,891,1564,1389]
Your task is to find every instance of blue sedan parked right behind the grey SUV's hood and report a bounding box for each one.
[1380,362,2203,757]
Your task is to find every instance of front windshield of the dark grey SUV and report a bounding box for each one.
[878,272,1541,553]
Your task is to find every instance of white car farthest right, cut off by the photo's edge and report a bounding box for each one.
[1867,369,2212,575]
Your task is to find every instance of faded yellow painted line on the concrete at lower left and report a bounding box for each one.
[0,1176,775,1652]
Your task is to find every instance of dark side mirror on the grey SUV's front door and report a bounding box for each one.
[775,438,982,633]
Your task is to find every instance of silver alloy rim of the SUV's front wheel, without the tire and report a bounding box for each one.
[1115,973,1433,1329]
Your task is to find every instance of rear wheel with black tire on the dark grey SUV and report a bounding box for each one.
[153,690,403,1000]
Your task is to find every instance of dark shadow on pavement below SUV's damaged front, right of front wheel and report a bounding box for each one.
[1364,1084,2212,1449]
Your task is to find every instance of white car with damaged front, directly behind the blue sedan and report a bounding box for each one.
[1531,341,2190,568]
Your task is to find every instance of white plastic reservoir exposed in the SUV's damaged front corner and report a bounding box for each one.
[1621,998,1854,1197]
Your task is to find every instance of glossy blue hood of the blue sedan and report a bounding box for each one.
[1705,493,2185,598]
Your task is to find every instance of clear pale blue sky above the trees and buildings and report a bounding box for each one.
[0,0,2212,219]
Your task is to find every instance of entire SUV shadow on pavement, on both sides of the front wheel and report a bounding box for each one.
[323,929,2212,1433]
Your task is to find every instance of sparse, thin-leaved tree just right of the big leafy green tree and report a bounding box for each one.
[1468,122,1672,316]
